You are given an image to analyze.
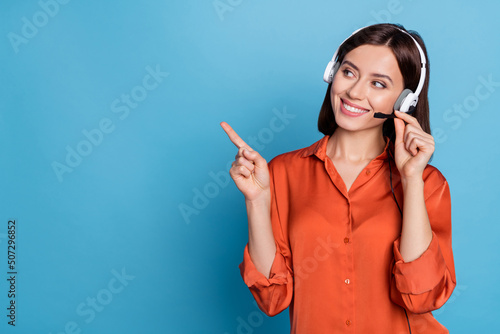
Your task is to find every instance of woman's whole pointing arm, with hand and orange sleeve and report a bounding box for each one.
[221,123,293,316]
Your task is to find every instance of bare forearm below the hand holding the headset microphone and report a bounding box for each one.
[400,176,432,262]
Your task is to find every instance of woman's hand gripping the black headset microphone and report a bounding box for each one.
[394,111,434,180]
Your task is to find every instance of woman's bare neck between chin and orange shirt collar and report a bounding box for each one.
[326,127,386,163]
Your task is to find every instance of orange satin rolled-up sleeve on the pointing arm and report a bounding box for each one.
[239,161,293,316]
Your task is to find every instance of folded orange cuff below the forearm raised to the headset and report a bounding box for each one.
[392,232,446,294]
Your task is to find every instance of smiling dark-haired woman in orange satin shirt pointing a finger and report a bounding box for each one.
[221,24,456,334]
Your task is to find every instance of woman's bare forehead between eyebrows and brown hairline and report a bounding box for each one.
[344,44,403,81]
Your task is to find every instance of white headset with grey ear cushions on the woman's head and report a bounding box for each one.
[323,26,427,113]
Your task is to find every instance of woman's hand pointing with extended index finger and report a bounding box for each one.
[220,122,271,201]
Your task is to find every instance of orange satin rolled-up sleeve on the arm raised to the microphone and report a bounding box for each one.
[391,169,456,313]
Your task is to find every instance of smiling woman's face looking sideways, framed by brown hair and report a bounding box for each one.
[330,44,404,131]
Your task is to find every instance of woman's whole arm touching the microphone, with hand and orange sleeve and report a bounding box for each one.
[391,111,456,313]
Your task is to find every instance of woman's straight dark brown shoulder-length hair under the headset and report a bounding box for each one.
[318,23,431,143]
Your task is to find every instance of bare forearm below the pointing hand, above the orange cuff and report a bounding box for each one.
[246,195,276,278]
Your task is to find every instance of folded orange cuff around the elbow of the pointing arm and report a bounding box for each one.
[239,244,288,287]
